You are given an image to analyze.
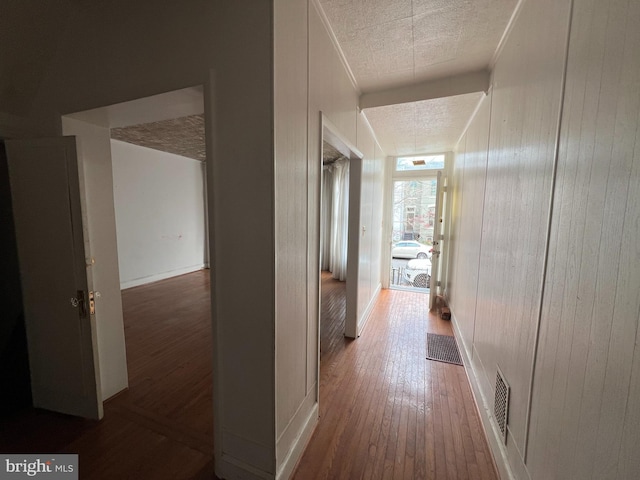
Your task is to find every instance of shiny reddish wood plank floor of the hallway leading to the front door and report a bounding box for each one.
[294,273,498,480]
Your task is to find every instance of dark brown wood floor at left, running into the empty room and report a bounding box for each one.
[0,270,215,480]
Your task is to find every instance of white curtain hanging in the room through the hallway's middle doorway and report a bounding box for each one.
[329,159,349,281]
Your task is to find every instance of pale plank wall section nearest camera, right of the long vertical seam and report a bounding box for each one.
[530,1,640,479]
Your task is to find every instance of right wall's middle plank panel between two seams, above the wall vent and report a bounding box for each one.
[474,0,570,462]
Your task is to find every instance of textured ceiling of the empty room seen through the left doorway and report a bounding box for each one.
[111,115,206,162]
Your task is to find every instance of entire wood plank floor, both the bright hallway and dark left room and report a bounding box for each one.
[0,271,497,480]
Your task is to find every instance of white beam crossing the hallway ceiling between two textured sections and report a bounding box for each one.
[360,70,491,110]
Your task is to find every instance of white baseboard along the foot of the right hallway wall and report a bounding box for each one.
[451,309,517,480]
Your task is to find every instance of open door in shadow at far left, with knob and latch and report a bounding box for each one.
[5,137,103,419]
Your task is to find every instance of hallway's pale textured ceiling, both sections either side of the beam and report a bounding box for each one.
[320,0,518,155]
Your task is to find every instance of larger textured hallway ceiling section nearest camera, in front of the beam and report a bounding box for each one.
[320,0,518,92]
